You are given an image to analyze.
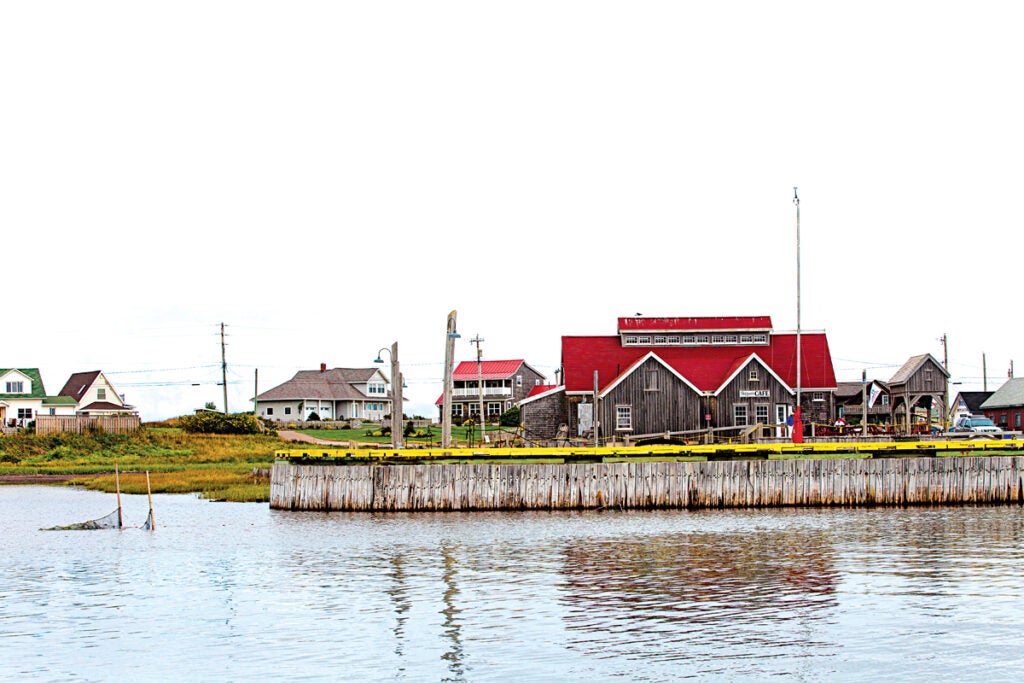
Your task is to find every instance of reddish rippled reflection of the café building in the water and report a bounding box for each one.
[561,530,838,660]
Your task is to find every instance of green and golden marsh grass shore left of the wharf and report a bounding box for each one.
[0,428,285,502]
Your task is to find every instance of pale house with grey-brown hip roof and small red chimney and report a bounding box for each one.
[253,364,391,422]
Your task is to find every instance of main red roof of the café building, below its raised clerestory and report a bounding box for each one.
[562,332,836,392]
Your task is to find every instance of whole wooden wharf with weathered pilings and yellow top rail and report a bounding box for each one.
[270,439,1024,511]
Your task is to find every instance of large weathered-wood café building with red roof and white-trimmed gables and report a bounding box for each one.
[520,315,837,439]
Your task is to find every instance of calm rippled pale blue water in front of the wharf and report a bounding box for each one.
[0,486,1024,681]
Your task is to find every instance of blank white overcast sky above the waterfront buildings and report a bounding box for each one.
[0,0,1024,420]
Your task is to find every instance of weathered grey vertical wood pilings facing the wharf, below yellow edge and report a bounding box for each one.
[270,456,1024,512]
